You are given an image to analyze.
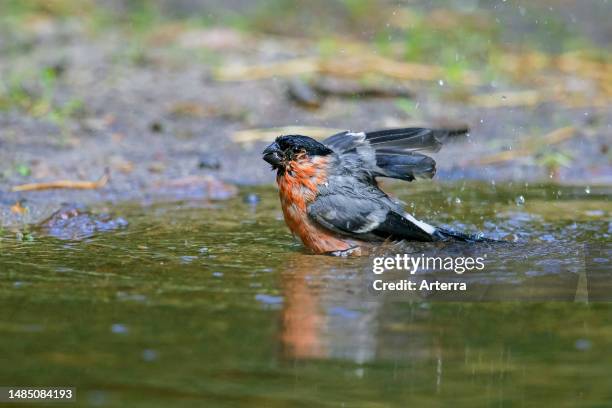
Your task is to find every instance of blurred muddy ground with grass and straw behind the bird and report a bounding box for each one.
[0,0,612,222]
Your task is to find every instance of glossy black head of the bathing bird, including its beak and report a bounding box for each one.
[263,135,333,169]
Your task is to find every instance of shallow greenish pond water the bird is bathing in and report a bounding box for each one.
[0,182,612,407]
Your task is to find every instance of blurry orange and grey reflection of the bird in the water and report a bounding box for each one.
[281,254,378,362]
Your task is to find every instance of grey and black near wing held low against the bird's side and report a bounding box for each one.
[308,192,436,241]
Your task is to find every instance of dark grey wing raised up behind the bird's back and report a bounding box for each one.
[323,128,468,181]
